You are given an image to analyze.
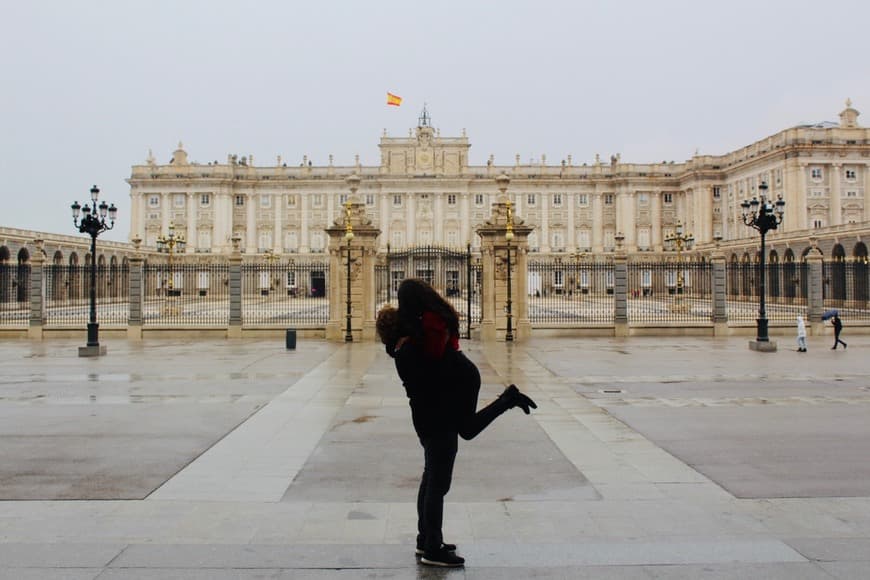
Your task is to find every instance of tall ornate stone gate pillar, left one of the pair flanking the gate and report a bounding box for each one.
[326,174,381,342]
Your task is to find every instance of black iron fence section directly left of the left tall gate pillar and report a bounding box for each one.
[242,261,329,327]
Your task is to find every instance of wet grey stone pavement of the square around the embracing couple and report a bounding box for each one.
[0,337,870,580]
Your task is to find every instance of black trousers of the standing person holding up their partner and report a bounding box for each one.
[417,431,458,553]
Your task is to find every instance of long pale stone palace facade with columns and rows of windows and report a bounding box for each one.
[128,101,870,258]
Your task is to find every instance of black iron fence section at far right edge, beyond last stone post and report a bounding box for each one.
[822,259,870,321]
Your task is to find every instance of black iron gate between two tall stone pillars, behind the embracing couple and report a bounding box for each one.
[375,246,482,338]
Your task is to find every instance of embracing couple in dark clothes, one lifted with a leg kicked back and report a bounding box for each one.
[376,279,537,567]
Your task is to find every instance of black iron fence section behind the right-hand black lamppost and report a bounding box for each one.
[725,262,809,324]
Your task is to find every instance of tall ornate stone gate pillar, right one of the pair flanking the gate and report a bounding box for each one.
[476,174,534,341]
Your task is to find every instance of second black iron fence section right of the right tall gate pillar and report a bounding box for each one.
[627,262,713,325]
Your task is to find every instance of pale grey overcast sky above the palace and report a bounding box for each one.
[0,0,870,240]
